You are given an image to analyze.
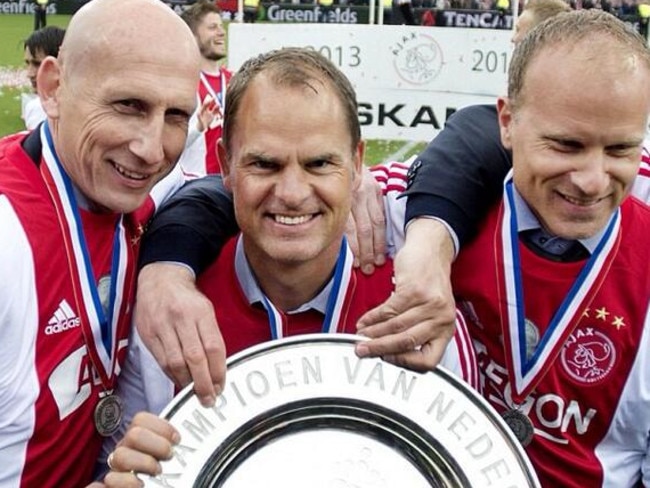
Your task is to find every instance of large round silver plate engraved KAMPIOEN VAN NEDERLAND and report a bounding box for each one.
[143,334,540,488]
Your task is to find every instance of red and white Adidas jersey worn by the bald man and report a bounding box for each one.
[0,133,180,488]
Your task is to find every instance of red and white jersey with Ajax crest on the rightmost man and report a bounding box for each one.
[452,198,650,488]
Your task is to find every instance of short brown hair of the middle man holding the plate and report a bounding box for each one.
[223,47,361,154]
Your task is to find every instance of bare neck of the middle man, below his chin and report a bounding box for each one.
[244,246,338,312]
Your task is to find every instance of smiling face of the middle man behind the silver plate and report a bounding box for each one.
[220,73,363,270]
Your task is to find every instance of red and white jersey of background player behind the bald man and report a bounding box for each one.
[179,66,232,177]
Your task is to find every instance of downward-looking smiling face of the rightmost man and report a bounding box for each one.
[498,38,650,239]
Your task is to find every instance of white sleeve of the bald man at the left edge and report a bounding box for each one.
[0,195,40,486]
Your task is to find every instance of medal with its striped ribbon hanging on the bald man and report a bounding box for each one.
[40,123,135,437]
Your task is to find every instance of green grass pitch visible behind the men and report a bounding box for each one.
[0,14,425,164]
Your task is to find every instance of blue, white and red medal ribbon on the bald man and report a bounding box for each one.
[40,122,129,390]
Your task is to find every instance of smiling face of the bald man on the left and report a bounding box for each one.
[38,2,199,212]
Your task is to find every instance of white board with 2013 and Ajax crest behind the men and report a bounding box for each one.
[228,23,512,141]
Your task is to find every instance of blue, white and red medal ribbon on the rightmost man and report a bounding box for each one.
[495,171,621,403]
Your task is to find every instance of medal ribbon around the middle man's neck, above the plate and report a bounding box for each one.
[263,237,354,340]
